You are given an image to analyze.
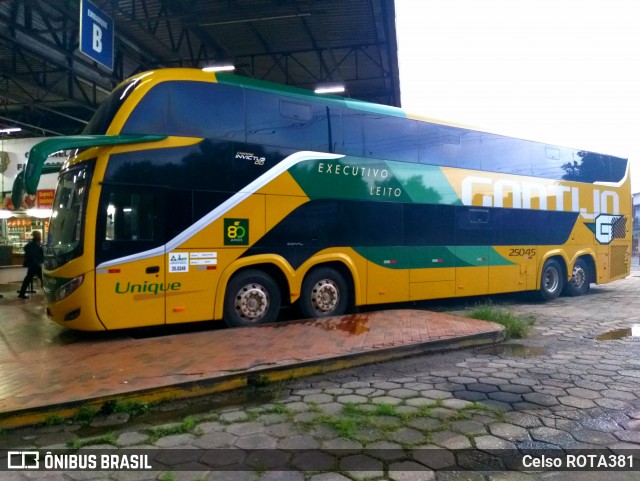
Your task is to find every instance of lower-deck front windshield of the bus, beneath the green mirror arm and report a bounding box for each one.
[45,162,92,269]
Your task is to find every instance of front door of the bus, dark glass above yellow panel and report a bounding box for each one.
[96,184,167,329]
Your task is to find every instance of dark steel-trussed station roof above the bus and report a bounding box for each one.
[0,0,400,138]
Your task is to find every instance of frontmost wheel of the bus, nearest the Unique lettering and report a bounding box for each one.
[224,269,281,327]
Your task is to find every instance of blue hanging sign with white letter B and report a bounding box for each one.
[80,0,114,70]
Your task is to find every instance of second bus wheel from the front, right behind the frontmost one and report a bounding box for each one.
[300,267,349,318]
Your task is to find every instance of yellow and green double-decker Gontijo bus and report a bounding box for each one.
[14,69,631,330]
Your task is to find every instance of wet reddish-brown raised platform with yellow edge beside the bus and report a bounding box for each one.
[0,284,504,428]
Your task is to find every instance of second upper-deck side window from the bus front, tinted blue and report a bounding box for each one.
[246,90,329,152]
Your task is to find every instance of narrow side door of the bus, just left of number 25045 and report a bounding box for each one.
[455,207,490,296]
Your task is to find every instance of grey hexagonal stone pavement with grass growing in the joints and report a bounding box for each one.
[0,259,640,481]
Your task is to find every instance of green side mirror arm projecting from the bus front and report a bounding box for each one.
[11,135,167,208]
